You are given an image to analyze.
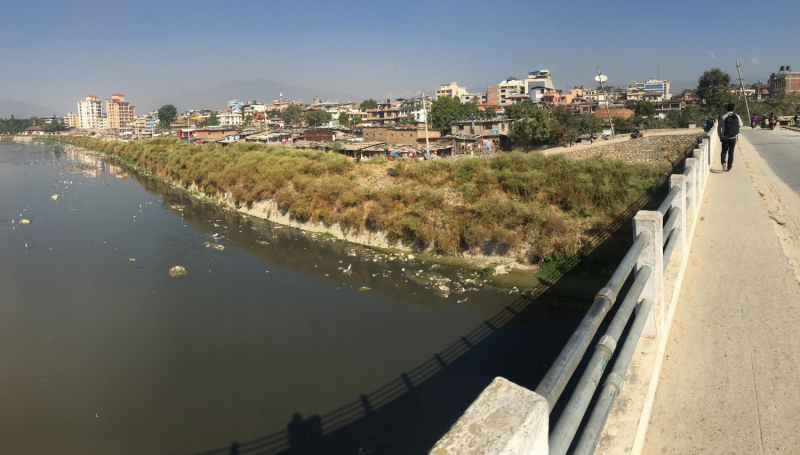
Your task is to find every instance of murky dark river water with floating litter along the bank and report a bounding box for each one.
[0,142,586,455]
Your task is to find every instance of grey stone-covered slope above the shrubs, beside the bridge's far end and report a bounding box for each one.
[564,131,703,164]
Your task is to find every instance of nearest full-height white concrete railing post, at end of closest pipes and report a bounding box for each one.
[633,210,666,338]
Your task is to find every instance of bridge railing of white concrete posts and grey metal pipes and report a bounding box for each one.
[431,130,716,455]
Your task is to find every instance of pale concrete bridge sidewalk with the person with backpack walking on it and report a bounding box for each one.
[643,141,800,454]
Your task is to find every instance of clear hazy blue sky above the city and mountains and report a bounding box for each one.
[0,0,800,113]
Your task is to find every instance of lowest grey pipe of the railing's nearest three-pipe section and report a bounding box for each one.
[573,299,653,455]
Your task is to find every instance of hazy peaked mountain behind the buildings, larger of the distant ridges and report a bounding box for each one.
[147,77,365,114]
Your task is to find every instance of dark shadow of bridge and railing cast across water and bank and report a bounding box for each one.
[189,160,682,455]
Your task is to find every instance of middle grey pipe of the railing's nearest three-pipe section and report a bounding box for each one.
[549,266,653,455]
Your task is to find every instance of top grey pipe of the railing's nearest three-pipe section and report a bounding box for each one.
[536,231,651,412]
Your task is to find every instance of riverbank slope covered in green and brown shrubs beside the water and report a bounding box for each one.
[43,137,668,274]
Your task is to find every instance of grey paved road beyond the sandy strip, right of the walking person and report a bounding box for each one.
[740,128,800,195]
